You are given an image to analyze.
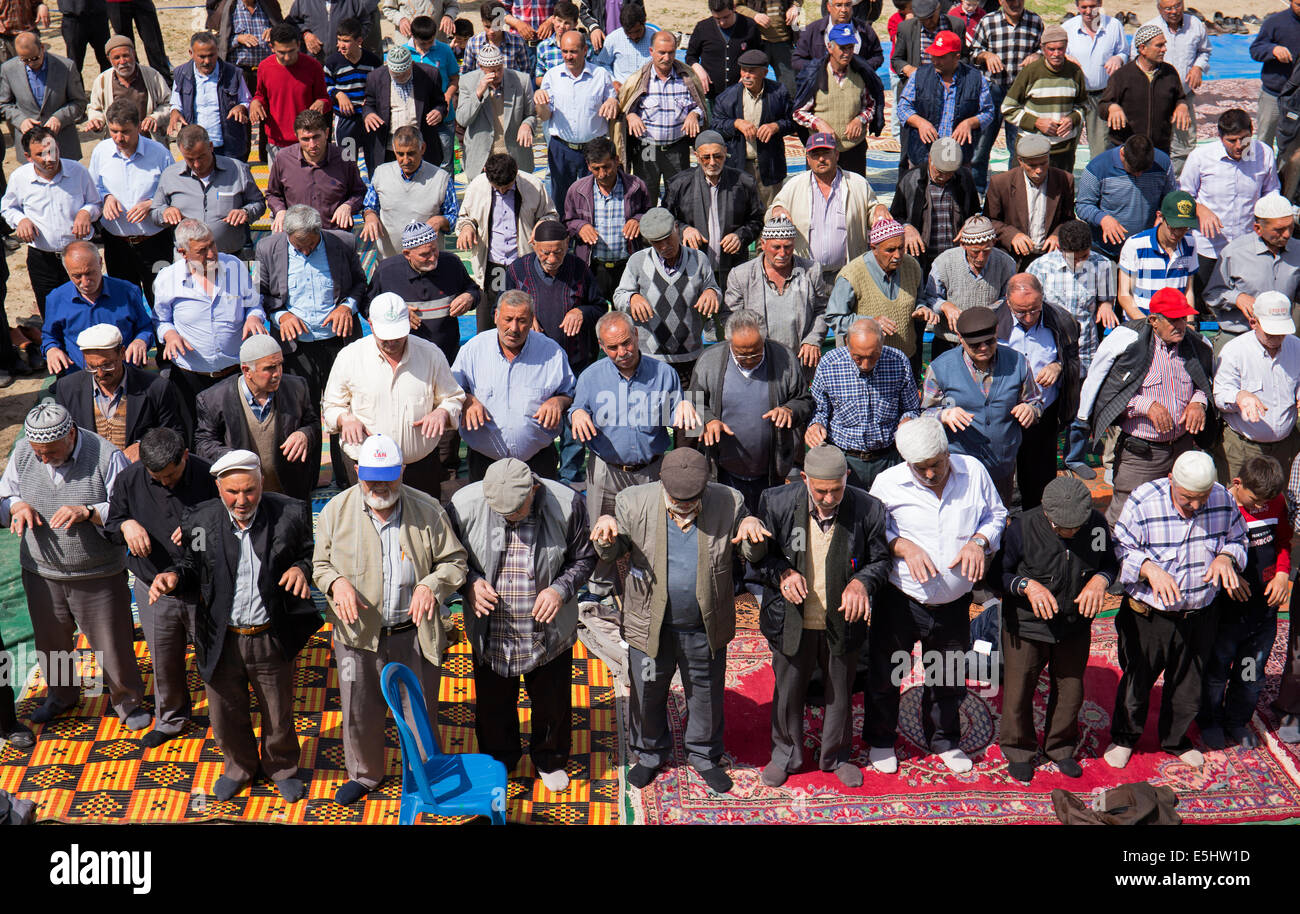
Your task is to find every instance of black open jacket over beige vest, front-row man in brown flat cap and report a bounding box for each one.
[758,481,891,657]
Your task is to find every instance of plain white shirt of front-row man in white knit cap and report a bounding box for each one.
[871,454,1006,606]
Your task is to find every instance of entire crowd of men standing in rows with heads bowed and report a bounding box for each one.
[0,0,1300,803]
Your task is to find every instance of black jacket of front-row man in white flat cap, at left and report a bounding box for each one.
[168,491,322,683]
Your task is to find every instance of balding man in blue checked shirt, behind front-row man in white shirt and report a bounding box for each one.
[803,317,920,489]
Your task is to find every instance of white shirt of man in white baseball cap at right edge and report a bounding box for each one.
[1214,332,1300,443]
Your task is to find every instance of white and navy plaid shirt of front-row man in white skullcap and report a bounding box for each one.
[1115,478,1247,612]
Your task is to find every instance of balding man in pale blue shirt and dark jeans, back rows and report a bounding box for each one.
[533,29,618,216]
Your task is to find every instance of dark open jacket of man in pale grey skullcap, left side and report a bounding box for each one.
[194,374,321,507]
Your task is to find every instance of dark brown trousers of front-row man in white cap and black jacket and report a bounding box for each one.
[208,631,300,784]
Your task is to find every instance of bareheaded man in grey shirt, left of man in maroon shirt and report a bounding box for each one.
[150,124,267,254]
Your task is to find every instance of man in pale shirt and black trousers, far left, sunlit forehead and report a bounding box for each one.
[0,124,100,317]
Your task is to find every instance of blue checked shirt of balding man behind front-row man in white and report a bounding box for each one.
[813,346,920,451]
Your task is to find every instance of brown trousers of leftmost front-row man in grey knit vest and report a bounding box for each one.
[22,568,144,720]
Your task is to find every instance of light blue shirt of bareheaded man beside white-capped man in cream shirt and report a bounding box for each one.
[451,329,575,460]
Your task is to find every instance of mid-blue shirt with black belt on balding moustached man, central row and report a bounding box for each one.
[569,355,681,464]
